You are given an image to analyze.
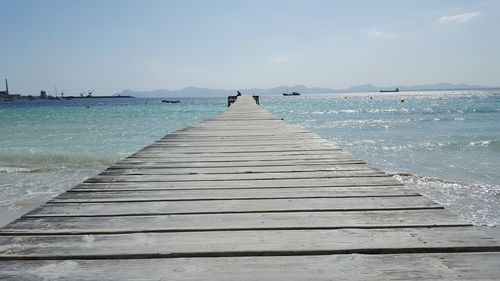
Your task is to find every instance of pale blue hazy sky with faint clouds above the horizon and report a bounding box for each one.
[0,0,500,95]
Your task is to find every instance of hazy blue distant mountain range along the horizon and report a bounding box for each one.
[115,83,488,97]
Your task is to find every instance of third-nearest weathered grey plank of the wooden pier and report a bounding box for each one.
[0,209,469,235]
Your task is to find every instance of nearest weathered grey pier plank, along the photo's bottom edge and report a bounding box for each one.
[0,253,500,281]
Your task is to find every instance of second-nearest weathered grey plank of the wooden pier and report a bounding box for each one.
[0,227,500,260]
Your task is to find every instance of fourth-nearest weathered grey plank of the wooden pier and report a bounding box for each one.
[27,196,442,217]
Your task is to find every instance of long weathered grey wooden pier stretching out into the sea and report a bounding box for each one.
[0,96,500,281]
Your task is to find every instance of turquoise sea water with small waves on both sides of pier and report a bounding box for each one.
[0,90,500,226]
